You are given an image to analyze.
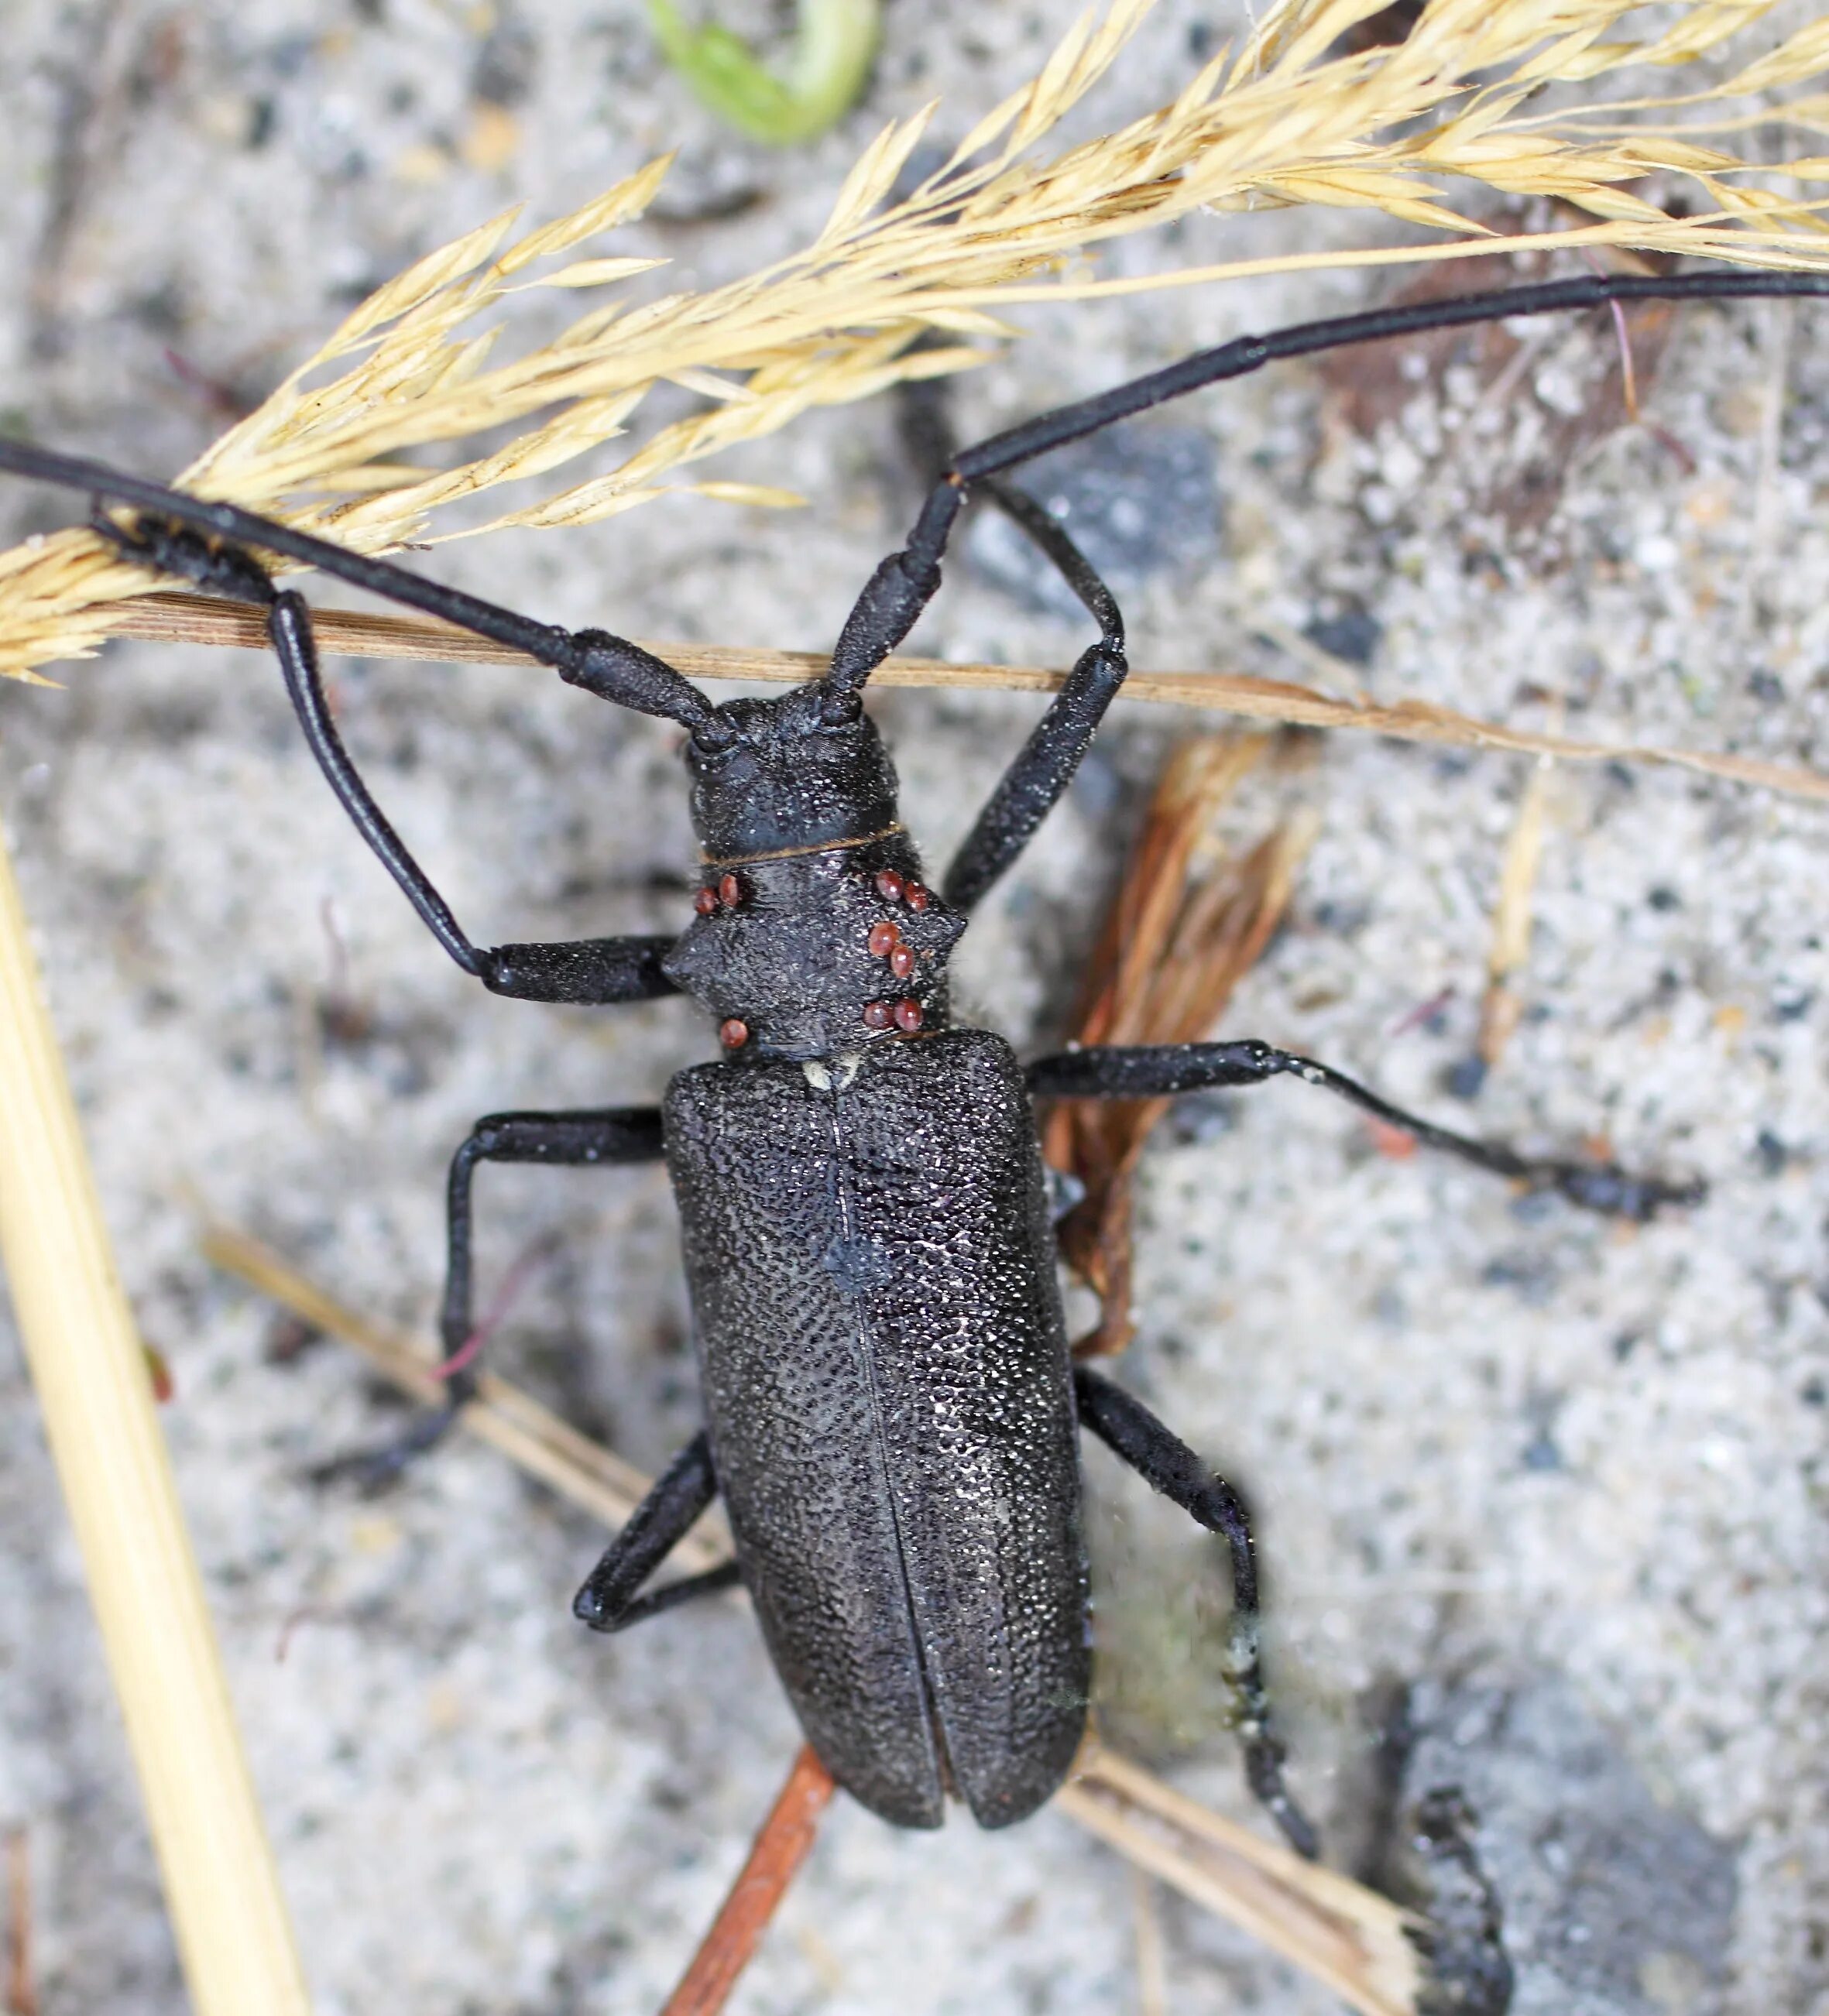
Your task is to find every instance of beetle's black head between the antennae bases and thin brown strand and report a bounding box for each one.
[685,680,895,861]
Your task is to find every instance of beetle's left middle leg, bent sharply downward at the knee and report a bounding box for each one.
[318,1107,664,1488]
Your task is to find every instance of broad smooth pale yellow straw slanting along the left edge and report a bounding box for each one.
[0,822,308,2016]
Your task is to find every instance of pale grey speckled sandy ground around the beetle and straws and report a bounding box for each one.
[0,0,1829,2016]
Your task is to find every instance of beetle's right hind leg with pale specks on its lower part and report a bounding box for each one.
[1072,1365,1321,1860]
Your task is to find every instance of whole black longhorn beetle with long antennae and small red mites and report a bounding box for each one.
[0,273,1829,1855]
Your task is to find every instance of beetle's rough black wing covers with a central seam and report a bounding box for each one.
[661,1028,1091,1826]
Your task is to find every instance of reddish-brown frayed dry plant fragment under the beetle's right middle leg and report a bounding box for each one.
[1042,735,1311,1356]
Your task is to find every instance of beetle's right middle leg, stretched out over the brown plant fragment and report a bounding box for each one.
[1028,1038,1708,1224]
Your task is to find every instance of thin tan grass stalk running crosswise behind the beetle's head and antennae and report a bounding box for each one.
[109,593,1829,798]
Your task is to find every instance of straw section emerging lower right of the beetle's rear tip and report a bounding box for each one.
[1055,1743,1422,2016]
